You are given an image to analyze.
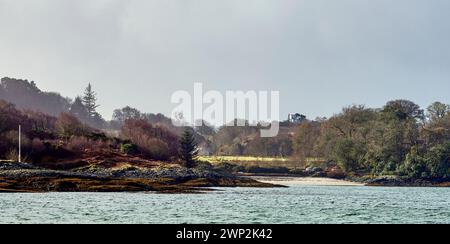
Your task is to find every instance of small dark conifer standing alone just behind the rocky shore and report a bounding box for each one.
[179,129,198,168]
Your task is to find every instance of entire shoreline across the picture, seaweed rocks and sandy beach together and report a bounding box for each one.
[0,163,450,193]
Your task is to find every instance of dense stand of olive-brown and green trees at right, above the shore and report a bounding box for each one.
[293,100,450,178]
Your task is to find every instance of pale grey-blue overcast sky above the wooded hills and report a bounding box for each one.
[0,0,450,119]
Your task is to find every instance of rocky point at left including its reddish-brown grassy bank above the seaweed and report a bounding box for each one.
[0,163,275,193]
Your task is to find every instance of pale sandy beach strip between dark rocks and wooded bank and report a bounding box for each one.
[252,176,364,186]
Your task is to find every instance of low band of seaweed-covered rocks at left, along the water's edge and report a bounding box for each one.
[0,174,278,194]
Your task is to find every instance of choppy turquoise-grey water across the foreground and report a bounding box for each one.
[0,186,450,224]
